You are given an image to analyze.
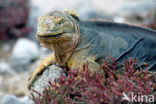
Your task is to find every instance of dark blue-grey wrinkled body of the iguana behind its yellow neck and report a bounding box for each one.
[76,21,156,70]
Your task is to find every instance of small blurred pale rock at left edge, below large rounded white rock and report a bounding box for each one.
[0,62,16,75]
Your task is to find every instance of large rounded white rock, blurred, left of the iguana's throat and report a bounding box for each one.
[11,38,39,72]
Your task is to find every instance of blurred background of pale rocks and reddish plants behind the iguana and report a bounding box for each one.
[0,0,156,104]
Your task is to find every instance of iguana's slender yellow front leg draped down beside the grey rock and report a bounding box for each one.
[28,53,56,89]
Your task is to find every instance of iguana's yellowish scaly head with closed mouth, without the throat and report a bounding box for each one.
[37,11,77,42]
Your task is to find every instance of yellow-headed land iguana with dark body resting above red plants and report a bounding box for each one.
[28,11,156,88]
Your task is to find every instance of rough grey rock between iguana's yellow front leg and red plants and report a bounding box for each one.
[33,65,65,96]
